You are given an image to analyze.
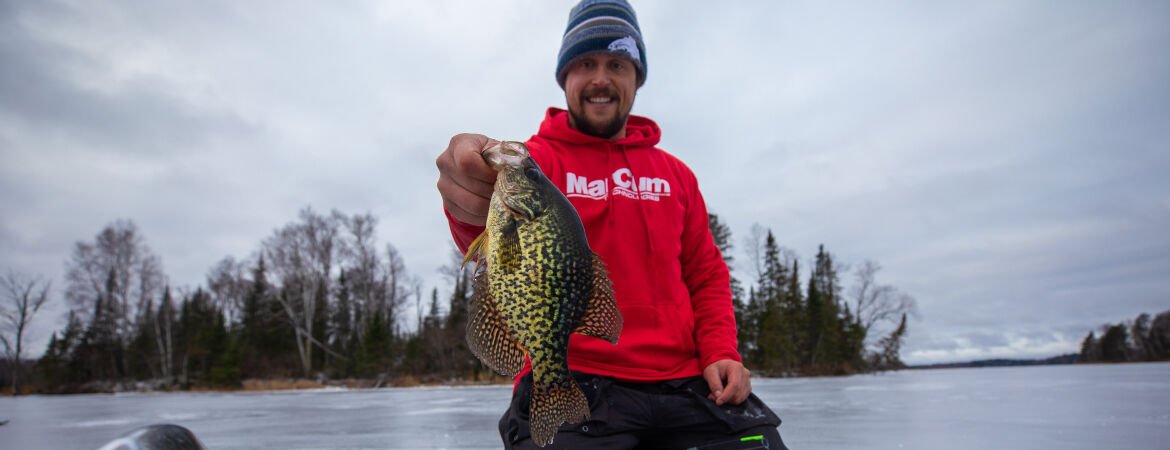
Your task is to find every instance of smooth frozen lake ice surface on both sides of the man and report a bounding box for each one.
[0,362,1170,449]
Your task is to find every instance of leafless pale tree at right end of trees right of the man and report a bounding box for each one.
[851,259,918,343]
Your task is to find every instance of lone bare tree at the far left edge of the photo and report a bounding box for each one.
[0,269,49,395]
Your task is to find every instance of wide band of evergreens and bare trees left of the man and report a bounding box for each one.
[23,208,486,392]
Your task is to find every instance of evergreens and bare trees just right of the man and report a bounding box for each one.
[709,214,917,376]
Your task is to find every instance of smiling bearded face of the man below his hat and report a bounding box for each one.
[565,55,638,140]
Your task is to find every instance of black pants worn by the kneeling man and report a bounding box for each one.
[500,372,787,450]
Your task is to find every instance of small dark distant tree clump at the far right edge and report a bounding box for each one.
[1078,310,1170,362]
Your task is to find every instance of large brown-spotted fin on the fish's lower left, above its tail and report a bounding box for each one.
[467,271,524,376]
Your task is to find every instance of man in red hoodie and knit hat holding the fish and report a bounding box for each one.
[436,0,784,449]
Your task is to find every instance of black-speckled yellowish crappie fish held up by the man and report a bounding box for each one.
[463,141,621,446]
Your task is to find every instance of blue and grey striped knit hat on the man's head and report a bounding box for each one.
[557,0,646,89]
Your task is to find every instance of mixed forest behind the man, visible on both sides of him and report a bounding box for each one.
[0,208,916,393]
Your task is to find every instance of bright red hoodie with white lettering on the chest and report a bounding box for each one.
[447,108,739,381]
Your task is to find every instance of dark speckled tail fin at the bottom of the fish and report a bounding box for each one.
[529,373,589,446]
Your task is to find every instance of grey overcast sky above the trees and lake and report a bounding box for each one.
[0,0,1170,364]
